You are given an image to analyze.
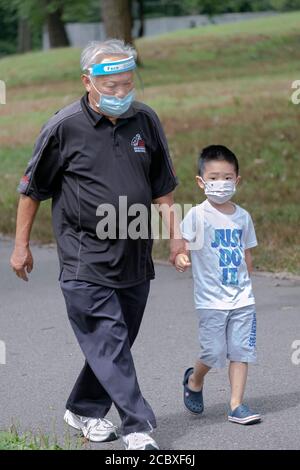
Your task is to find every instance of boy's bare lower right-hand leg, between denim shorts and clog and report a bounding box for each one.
[228,361,248,410]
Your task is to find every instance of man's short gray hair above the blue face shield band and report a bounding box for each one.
[80,39,137,72]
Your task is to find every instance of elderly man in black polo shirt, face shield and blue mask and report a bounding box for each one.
[11,40,185,450]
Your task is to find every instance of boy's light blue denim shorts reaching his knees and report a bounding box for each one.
[197,304,256,367]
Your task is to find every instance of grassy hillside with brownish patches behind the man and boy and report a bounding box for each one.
[0,12,300,274]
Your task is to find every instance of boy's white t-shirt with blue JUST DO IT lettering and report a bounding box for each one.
[180,200,257,310]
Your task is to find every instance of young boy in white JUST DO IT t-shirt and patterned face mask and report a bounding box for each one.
[175,145,261,424]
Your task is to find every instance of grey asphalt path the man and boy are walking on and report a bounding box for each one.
[0,240,300,450]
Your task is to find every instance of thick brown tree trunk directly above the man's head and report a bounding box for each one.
[101,0,132,44]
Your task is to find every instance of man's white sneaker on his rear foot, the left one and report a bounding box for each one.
[64,410,119,442]
